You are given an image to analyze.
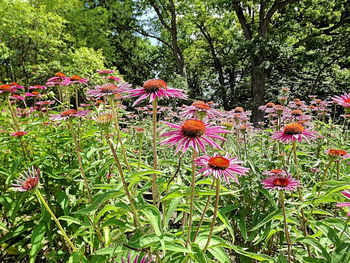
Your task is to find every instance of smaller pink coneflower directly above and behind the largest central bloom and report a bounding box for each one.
[180,100,222,119]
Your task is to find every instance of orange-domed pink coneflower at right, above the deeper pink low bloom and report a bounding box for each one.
[271,123,316,143]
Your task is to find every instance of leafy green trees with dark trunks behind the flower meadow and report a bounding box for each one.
[0,0,350,122]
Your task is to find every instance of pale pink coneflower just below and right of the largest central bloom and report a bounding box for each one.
[195,153,249,184]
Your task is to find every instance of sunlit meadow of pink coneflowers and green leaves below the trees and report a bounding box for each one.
[0,70,350,263]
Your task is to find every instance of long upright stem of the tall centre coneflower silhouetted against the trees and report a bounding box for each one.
[152,97,158,206]
